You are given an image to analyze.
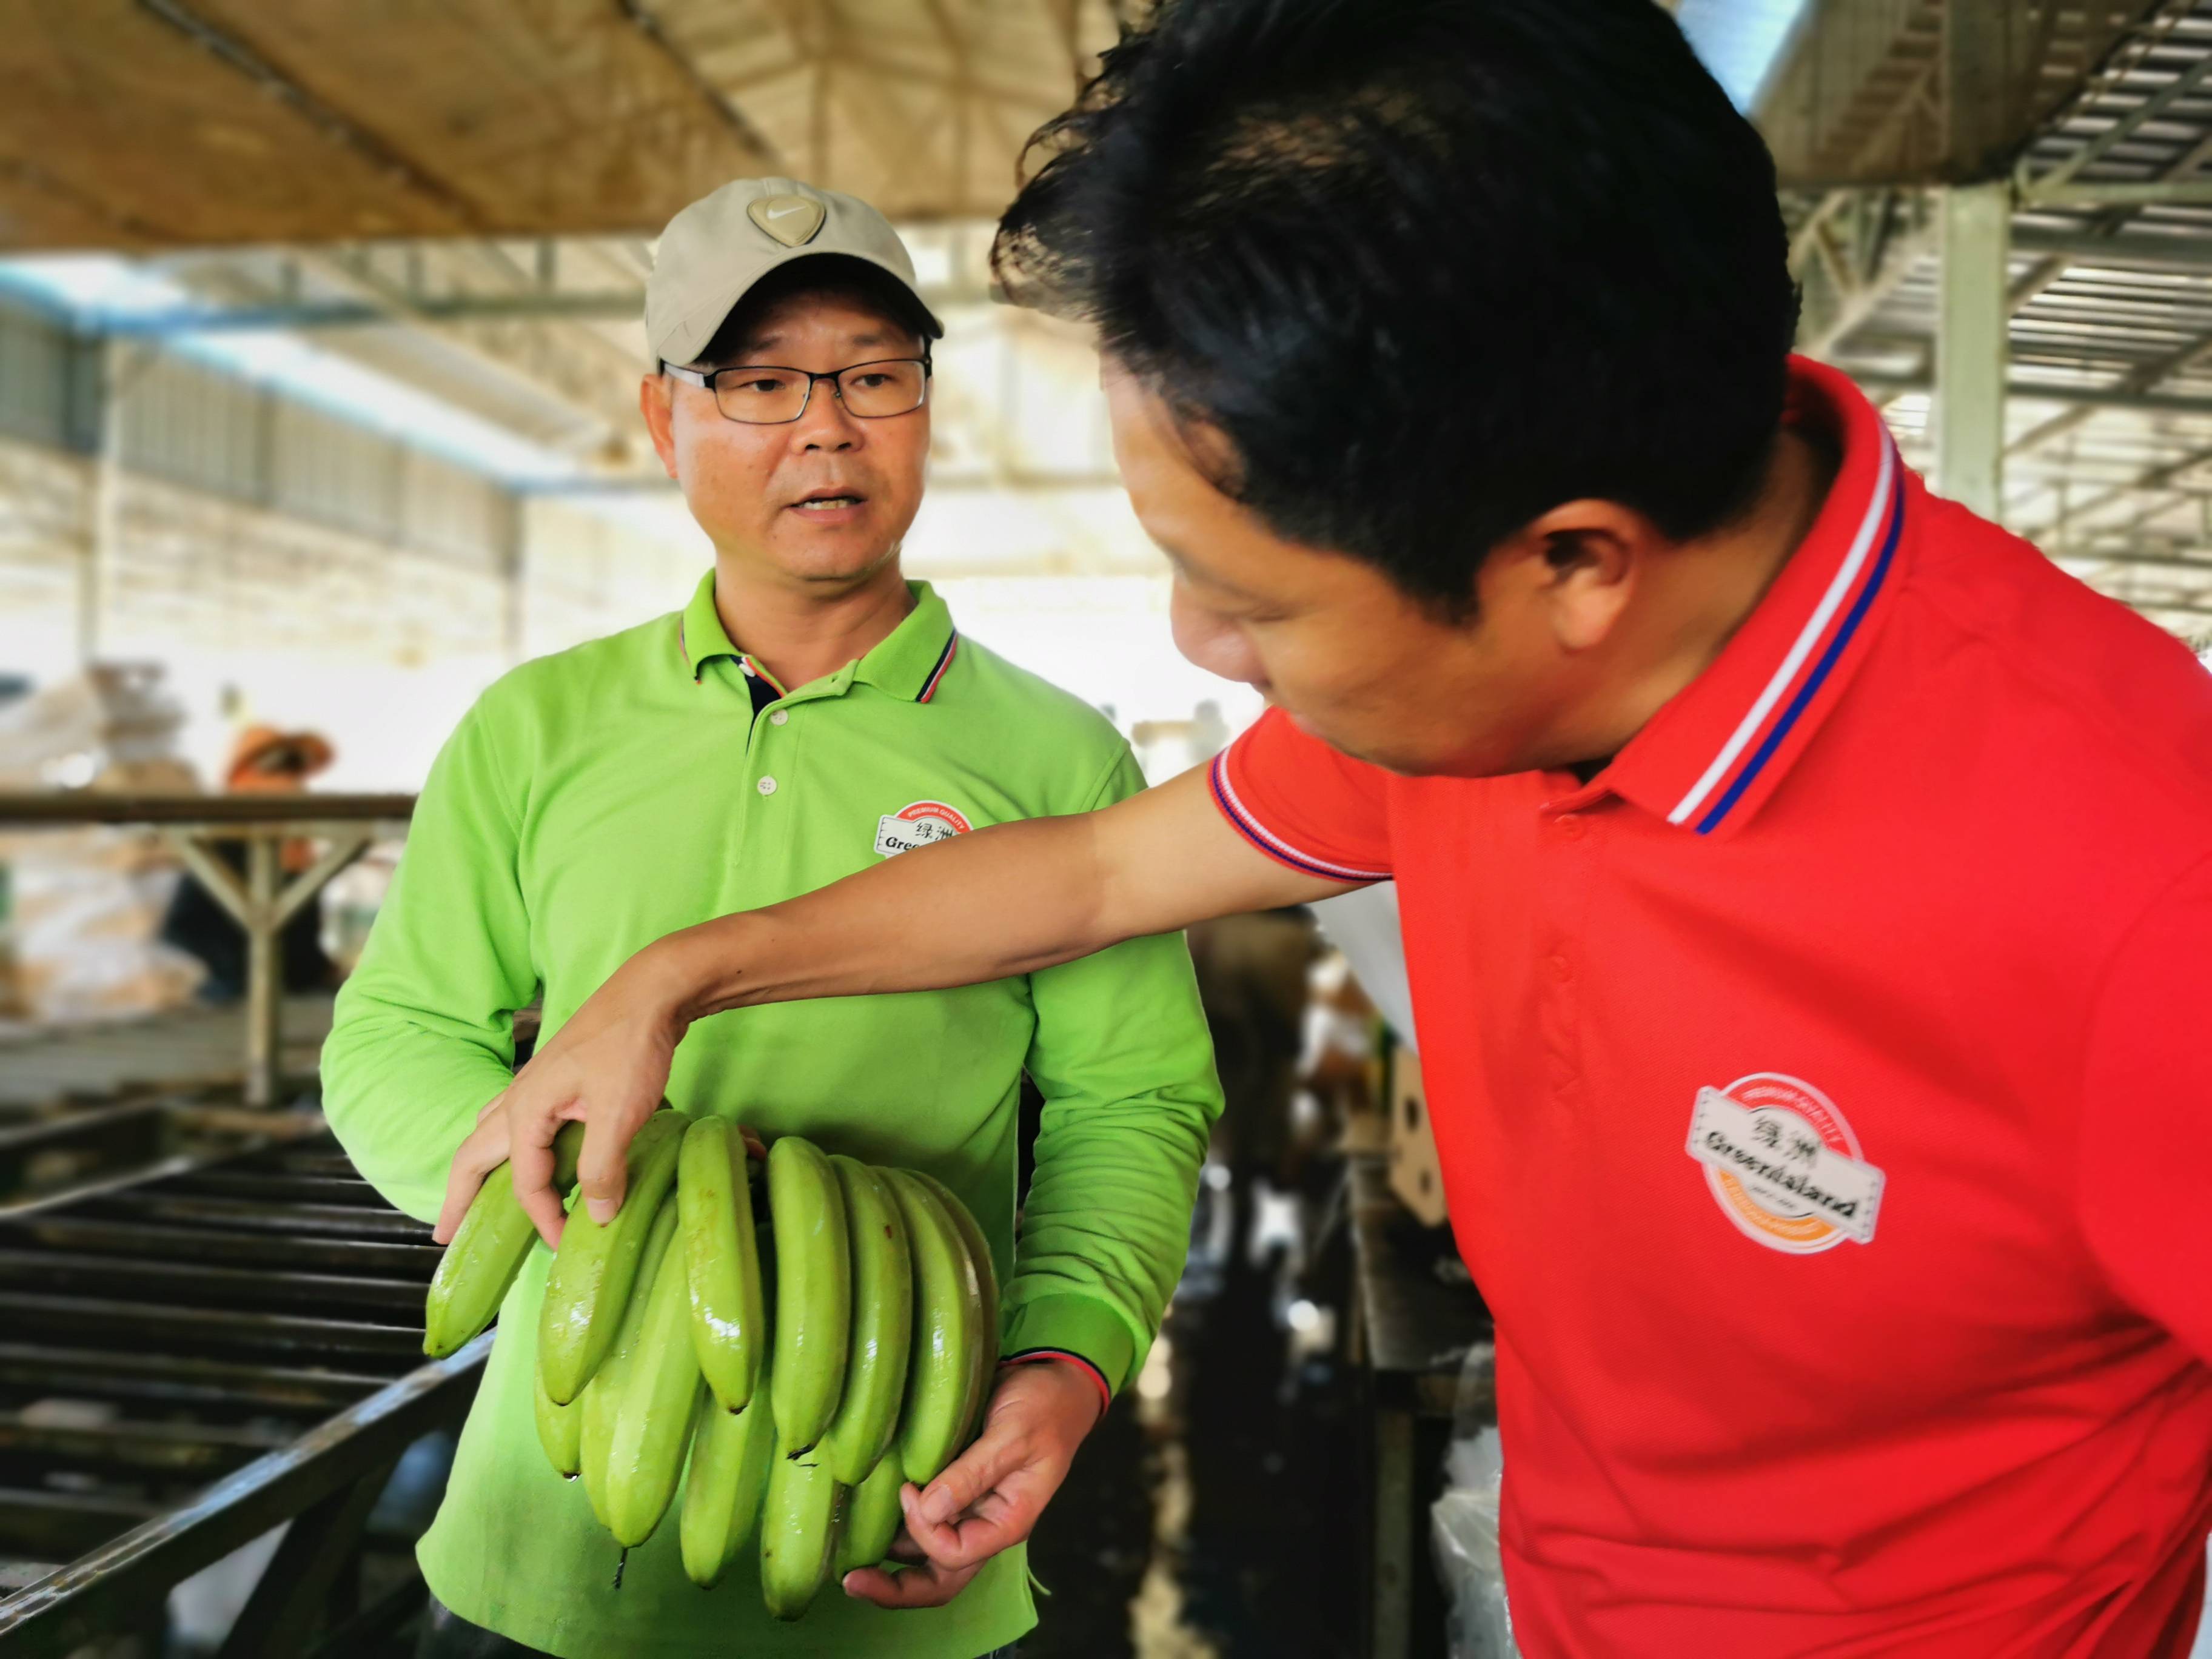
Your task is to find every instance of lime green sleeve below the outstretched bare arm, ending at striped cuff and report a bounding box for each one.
[1000,748,1221,1392]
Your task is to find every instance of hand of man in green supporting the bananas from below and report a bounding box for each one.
[845,1362,1102,1608]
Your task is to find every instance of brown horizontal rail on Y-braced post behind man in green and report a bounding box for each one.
[0,789,414,1106]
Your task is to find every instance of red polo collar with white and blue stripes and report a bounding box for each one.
[1593,358,1907,836]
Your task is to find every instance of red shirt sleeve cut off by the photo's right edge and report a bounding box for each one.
[2079,860,2212,1361]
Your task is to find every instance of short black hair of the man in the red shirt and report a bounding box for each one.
[991,0,1798,615]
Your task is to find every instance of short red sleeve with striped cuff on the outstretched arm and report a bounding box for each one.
[1210,708,1392,880]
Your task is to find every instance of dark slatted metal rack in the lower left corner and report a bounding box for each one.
[0,1124,482,1659]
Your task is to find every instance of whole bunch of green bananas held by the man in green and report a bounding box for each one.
[502,1110,1000,1619]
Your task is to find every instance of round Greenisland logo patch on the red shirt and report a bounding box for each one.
[1686,1071,1885,1256]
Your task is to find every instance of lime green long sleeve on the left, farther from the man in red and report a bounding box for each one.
[323,703,537,1221]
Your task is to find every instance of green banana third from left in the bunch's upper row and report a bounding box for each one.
[677,1117,768,1411]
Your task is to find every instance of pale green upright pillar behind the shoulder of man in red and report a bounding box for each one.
[1936,179,2013,518]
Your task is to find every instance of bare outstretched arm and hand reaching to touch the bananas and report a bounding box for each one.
[438,768,1349,1243]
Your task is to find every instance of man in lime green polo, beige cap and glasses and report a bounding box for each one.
[323,179,1219,1659]
